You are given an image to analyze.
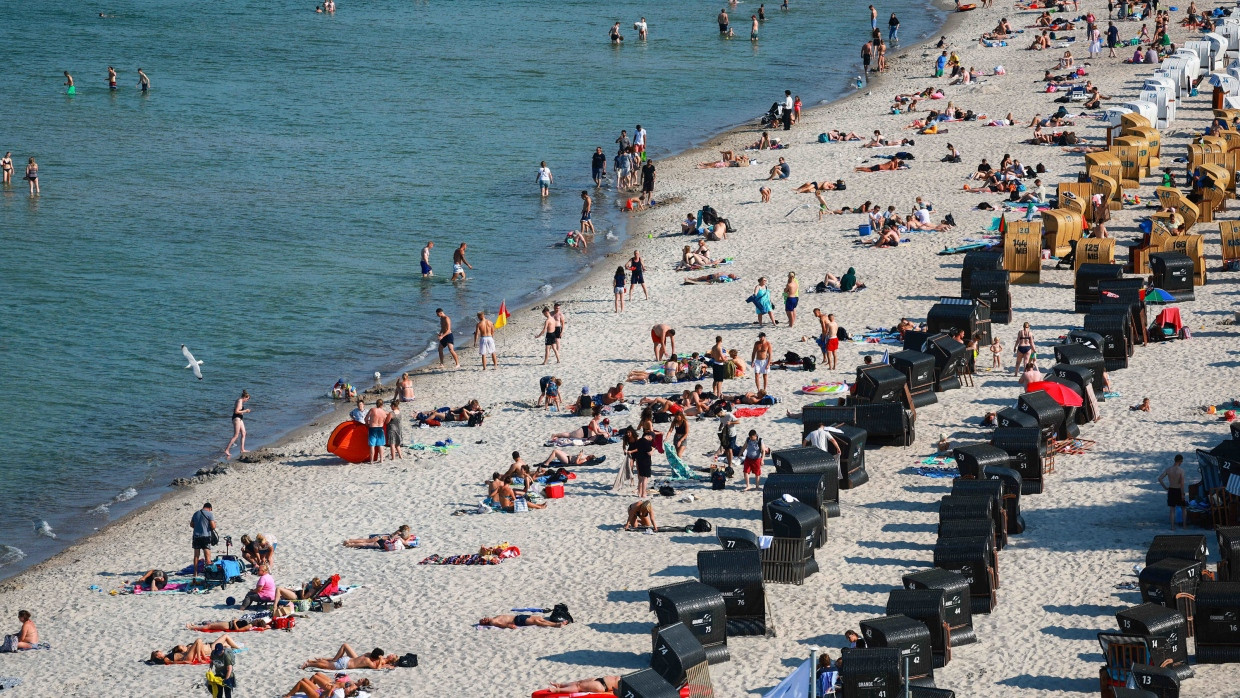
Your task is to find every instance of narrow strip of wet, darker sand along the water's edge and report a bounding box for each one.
[0,0,962,589]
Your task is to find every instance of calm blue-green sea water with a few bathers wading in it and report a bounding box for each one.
[0,0,941,577]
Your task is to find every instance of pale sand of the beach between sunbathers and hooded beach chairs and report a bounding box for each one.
[0,1,1240,698]
